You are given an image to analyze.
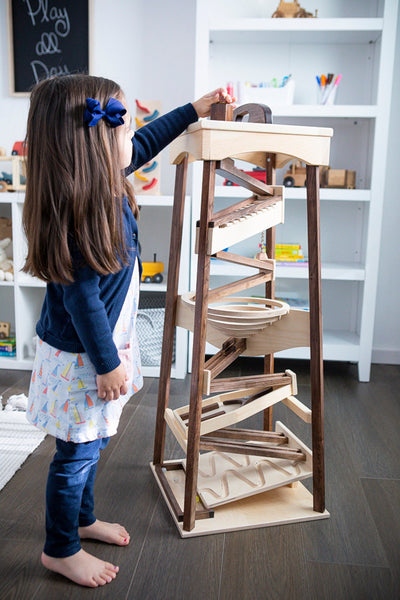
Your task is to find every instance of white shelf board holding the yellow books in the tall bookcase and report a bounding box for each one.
[210,260,365,281]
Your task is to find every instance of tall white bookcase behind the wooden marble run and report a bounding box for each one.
[191,0,398,381]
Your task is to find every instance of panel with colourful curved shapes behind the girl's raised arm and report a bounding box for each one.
[133,100,161,195]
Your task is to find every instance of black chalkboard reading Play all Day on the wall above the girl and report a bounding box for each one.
[8,0,90,95]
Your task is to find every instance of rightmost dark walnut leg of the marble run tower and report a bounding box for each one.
[306,165,325,512]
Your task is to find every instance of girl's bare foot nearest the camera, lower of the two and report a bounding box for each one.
[42,549,119,587]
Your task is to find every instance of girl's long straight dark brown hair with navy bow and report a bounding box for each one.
[22,75,137,284]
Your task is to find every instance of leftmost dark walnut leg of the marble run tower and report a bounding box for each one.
[153,155,188,465]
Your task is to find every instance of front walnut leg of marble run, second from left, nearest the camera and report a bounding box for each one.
[183,161,216,531]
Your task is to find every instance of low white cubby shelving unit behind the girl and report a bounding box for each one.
[0,192,190,378]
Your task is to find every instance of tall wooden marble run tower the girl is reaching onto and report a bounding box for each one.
[151,104,333,537]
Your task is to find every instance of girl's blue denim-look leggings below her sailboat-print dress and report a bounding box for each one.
[44,438,110,558]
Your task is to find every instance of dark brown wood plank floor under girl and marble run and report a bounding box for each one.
[0,359,400,600]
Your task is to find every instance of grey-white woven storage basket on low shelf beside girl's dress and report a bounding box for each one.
[136,308,175,367]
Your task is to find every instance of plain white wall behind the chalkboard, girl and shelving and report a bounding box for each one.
[0,0,400,363]
